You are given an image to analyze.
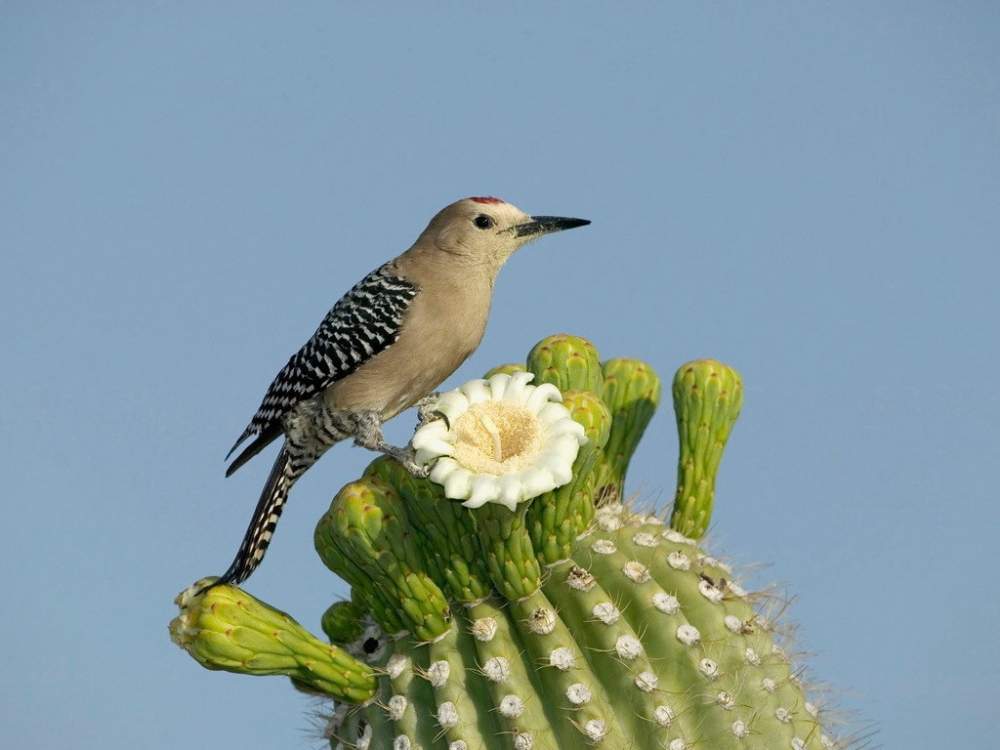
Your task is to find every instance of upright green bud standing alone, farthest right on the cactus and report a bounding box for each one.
[670,359,743,539]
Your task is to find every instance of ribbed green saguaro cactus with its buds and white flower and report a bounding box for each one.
[171,336,848,750]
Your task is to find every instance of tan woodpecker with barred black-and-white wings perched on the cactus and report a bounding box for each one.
[211,198,590,586]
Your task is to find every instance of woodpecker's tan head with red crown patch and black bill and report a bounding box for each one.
[414,198,590,273]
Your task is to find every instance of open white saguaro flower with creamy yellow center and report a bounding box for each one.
[411,372,587,510]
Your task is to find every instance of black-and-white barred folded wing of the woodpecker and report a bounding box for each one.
[226,264,418,476]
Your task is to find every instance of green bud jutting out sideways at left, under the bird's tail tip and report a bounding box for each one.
[170,579,377,703]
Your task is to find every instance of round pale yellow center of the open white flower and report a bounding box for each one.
[452,401,544,476]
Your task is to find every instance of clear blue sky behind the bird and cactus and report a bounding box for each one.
[0,1,1000,748]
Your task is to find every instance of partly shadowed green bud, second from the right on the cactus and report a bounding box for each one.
[597,358,660,506]
